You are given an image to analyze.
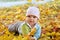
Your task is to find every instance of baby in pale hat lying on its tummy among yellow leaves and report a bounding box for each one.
[8,6,41,40]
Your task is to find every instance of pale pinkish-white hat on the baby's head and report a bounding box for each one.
[26,7,40,18]
